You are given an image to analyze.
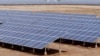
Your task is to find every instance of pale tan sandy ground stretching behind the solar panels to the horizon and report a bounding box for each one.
[0,5,100,15]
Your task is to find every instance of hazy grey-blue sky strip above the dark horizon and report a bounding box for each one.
[0,0,100,5]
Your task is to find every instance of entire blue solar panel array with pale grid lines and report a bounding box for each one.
[0,10,100,49]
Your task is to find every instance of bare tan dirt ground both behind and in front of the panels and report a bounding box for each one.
[0,5,100,56]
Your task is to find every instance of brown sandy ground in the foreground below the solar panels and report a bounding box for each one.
[0,43,100,56]
